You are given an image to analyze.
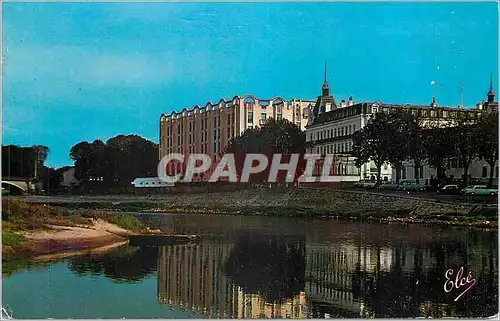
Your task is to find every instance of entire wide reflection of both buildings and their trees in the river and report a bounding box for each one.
[158,232,498,318]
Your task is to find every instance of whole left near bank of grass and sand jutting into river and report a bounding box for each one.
[2,201,142,262]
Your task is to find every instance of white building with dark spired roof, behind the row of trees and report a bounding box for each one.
[306,76,498,181]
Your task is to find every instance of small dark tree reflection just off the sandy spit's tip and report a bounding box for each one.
[68,245,158,283]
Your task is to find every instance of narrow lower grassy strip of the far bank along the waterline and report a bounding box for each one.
[42,201,498,229]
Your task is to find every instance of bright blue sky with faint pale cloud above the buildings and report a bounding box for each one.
[2,2,498,166]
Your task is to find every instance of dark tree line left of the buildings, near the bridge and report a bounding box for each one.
[2,135,158,193]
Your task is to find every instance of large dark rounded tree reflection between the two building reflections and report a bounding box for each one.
[224,233,305,302]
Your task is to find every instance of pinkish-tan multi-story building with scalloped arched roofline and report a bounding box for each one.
[159,95,314,175]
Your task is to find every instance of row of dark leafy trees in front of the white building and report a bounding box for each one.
[352,110,498,187]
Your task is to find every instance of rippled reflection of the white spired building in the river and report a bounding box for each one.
[305,244,440,317]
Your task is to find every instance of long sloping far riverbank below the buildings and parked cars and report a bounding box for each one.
[9,188,498,229]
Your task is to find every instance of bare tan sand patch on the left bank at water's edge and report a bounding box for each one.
[23,219,130,256]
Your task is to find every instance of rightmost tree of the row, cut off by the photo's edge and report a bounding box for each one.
[475,112,498,188]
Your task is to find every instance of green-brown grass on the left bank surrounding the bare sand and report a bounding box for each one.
[2,200,143,261]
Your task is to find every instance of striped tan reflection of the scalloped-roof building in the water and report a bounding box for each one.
[157,242,306,318]
